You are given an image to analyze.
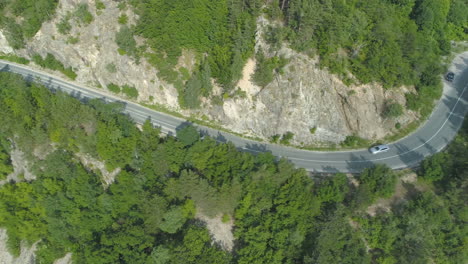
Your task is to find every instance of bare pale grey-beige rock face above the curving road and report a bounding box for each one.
[0,0,417,145]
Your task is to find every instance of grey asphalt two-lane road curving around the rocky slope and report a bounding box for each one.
[0,52,468,173]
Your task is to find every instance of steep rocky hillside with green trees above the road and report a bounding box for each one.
[0,0,467,146]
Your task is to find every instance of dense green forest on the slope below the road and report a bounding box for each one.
[0,73,468,264]
